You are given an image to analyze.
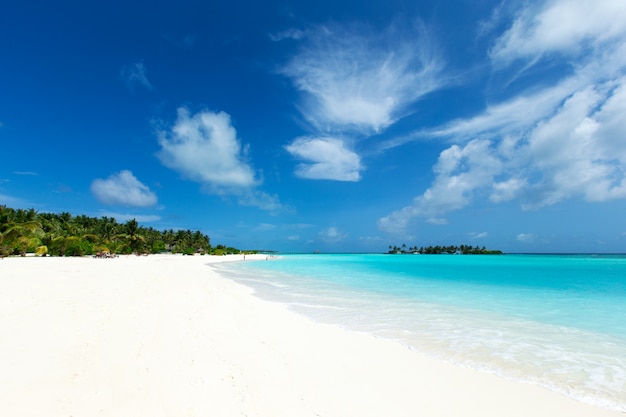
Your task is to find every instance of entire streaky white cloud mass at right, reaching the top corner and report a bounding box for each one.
[379,0,626,232]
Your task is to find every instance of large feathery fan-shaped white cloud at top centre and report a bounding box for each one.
[281,22,442,132]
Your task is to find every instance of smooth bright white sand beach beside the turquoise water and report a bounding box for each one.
[0,255,623,417]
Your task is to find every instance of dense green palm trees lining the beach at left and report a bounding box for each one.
[0,205,250,256]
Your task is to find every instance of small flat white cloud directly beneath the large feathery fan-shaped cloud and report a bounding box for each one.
[285,137,363,181]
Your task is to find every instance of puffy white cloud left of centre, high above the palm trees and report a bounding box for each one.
[158,108,257,191]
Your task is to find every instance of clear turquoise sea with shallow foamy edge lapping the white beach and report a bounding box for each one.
[216,255,626,412]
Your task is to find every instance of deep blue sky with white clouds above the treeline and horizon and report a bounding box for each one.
[0,0,626,252]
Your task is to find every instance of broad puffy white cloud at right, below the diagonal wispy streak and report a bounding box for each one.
[379,79,626,231]
